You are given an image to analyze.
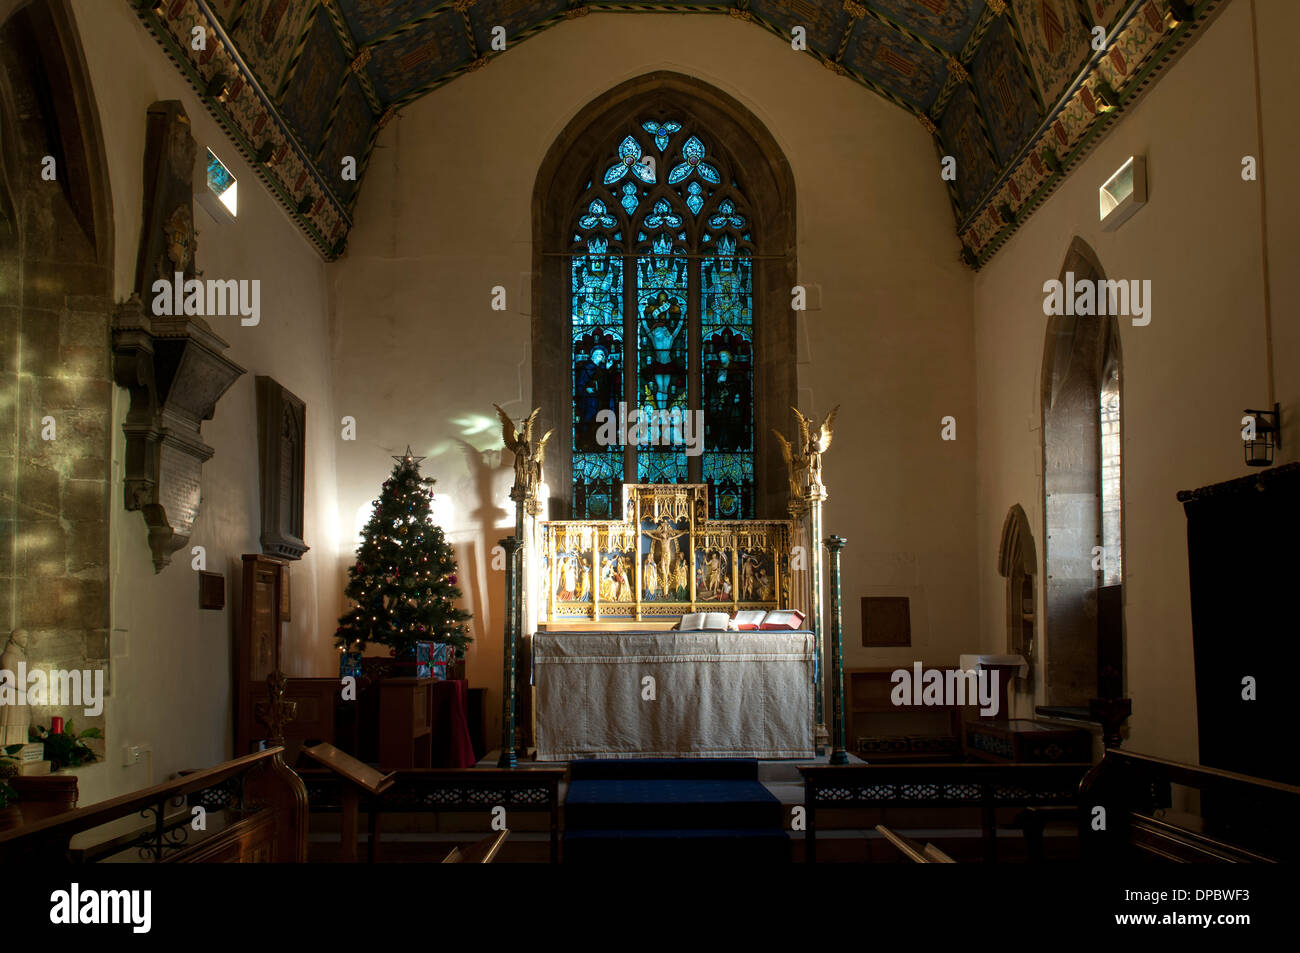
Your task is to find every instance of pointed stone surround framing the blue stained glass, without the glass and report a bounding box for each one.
[532,70,798,517]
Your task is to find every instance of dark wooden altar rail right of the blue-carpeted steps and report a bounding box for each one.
[800,763,1091,863]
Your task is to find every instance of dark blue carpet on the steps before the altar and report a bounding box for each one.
[564,758,790,863]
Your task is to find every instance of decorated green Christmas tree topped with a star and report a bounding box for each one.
[334,447,469,658]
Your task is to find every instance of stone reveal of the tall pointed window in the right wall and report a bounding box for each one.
[1041,237,1119,707]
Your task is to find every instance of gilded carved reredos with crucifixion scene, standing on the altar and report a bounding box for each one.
[538,484,793,623]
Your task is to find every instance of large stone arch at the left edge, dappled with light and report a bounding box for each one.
[0,0,114,728]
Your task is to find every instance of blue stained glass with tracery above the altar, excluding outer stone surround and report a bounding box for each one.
[568,113,755,519]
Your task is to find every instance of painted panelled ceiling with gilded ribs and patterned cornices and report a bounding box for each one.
[137,0,1222,268]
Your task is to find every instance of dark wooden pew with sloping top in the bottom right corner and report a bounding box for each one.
[1079,749,1300,863]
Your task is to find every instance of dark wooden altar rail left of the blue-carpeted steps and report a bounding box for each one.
[299,766,564,863]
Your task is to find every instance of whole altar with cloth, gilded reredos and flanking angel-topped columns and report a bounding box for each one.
[497,407,848,767]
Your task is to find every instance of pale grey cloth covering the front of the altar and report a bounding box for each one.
[532,631,814,761]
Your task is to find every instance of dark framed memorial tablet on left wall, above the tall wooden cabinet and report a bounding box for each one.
[257,377,309,559]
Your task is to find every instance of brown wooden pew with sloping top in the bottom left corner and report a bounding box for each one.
[0,748,307,865]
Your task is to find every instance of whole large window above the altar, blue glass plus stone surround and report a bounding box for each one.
[529,72,798,519]
